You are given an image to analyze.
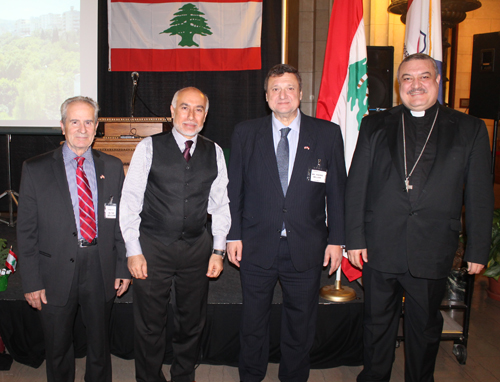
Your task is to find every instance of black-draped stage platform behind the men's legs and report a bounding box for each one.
[0,226,363,369]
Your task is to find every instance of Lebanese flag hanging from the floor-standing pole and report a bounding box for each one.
[316,0,368,281]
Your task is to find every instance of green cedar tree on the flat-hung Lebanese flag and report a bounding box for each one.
[160,3,212,46]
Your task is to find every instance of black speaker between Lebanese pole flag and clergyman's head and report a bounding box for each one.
[366,46,394,111]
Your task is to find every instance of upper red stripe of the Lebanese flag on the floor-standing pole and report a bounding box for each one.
[316,0,363,121]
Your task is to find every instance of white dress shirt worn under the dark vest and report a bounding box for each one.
[120,128,231,257]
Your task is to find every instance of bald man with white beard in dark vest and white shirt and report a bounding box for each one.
[120,87,231,382]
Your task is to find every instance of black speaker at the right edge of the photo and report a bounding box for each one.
[469,32,500,119]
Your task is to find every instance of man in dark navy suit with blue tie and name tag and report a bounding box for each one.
[227,64,346,382]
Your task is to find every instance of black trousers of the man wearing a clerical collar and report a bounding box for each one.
[357,264,446,382]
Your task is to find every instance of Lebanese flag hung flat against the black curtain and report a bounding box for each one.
[108,0,262,72]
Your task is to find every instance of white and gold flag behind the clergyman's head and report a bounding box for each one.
[404,0,443,104]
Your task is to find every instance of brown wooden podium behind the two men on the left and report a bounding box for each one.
[93,117,172,174]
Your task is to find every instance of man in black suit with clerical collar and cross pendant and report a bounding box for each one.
[346,54,493,381]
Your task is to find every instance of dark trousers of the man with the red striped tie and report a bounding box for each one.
[40,246,113,382]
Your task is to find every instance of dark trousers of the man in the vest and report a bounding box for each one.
[133,232,212,382]
